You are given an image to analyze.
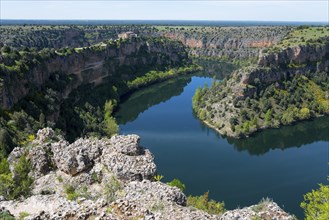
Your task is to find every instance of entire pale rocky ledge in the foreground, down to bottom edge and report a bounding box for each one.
[0,128,293,220]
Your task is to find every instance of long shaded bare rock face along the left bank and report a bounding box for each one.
[0,38,187,109]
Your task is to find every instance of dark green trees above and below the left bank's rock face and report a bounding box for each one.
[0,33,199,157]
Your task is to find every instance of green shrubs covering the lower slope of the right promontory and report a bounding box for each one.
[193,67,329,136]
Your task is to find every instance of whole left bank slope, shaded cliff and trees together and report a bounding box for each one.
[0,37,197,154]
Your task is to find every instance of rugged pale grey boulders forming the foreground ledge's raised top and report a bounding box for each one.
[28,128,156,181]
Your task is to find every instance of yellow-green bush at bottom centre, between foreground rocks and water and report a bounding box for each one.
[187,192,225,214]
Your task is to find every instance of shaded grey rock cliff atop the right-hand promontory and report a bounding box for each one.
[238,41,329,96]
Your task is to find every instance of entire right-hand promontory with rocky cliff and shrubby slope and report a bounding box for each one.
[193,27,329,137]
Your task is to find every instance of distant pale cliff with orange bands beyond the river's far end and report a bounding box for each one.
[160,27,291,58]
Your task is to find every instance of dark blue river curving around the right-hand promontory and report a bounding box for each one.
[116,71,329,218]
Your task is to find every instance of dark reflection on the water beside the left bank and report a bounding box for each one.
[115,76,191,125]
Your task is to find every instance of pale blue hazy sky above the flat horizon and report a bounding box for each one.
[0,0,329,23]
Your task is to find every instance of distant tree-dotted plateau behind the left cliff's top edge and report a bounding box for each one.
[0,25,152,50]
